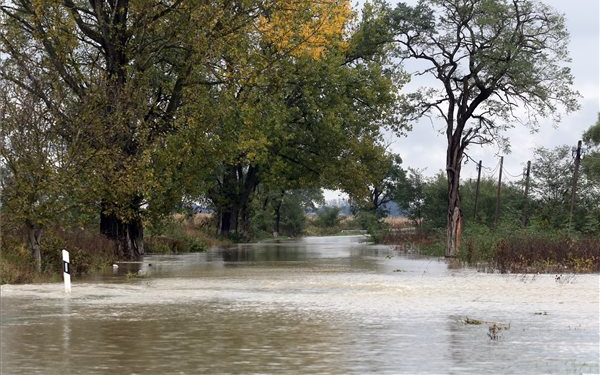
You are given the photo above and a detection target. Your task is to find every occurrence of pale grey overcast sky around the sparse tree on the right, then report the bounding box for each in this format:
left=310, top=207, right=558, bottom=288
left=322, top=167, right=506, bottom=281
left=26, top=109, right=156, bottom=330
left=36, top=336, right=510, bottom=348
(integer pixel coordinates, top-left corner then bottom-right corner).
left=326, top=0, right=600, bottom=203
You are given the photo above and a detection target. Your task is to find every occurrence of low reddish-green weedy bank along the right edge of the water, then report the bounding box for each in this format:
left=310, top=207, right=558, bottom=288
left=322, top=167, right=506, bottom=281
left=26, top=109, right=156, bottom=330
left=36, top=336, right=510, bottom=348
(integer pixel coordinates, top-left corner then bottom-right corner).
left=381, top=225, right=600, bottom=273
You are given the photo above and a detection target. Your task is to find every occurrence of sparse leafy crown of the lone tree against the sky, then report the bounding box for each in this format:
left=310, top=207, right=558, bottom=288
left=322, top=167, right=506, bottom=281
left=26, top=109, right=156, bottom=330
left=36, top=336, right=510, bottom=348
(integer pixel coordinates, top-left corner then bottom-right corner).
left=388, top=0, right=578, bottom=126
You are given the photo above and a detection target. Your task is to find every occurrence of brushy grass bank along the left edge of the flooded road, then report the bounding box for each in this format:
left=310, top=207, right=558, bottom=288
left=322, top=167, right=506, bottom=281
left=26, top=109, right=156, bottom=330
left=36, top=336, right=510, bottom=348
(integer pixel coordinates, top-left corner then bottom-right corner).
left=0, top=215, right=225, bottom=284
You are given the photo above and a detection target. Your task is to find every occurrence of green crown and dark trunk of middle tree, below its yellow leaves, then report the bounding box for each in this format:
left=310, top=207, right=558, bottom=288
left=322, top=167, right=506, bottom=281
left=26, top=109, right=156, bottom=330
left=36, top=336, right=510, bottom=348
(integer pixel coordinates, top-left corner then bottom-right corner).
left=195, top=18, right=400, bottom=238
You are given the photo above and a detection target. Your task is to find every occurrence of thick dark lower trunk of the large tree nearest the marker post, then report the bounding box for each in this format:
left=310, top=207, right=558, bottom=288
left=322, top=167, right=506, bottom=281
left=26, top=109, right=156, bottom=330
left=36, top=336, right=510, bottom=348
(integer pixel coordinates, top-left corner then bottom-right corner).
left=100, top=204, right=145, bottom=259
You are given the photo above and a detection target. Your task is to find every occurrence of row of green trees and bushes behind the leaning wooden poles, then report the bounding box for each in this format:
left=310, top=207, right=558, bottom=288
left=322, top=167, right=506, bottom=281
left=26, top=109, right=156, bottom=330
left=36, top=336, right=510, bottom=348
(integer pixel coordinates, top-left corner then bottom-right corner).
left=396, top=120, right=600, bottom=236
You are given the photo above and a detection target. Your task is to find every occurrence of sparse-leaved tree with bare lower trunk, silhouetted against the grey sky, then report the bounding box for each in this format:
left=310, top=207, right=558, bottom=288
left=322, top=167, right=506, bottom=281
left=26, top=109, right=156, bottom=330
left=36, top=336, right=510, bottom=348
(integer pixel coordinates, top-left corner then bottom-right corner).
left=388, top=0, right=578, bottom=257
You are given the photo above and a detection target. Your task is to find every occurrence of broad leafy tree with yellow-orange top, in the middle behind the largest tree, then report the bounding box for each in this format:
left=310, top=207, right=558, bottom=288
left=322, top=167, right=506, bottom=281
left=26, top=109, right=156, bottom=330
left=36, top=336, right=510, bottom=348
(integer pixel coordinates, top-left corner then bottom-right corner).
left=193, top=1, right=406, bottom=238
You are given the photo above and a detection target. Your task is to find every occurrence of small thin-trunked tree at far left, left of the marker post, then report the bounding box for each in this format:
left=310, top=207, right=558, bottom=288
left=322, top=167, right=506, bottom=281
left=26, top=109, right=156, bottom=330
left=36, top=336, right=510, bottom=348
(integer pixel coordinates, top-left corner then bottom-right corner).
left=0, top=72, right=91, bottom=272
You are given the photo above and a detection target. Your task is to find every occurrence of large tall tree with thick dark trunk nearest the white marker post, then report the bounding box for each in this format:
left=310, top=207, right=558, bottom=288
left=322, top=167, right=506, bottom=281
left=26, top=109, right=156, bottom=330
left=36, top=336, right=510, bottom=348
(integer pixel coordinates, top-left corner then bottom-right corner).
left=0, top=0, right=260, bottom=258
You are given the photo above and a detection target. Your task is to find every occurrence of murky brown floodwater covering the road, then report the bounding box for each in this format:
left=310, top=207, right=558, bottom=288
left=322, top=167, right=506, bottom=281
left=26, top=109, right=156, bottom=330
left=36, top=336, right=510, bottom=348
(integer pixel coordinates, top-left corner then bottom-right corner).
left=0, top=236, right=600, bottom=375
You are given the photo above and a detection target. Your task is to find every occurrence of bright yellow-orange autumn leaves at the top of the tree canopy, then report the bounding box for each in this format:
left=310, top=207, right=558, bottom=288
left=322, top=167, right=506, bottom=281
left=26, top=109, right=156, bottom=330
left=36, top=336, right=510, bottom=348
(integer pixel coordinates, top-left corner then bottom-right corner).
left=258, top=0, right=353, bottom=59
